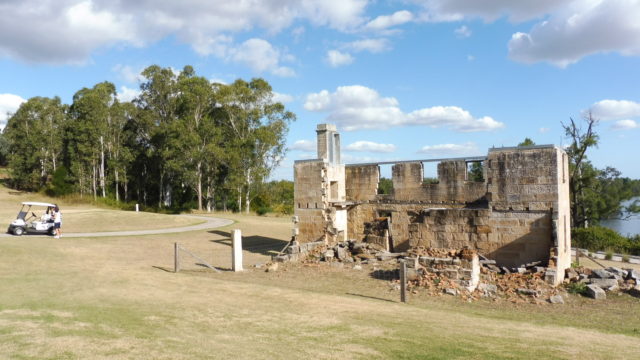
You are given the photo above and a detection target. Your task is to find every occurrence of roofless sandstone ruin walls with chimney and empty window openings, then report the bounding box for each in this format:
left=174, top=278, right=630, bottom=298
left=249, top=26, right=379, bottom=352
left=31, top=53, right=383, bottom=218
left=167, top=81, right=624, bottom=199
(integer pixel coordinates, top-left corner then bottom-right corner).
left=289, top=124, right=571, bottom=285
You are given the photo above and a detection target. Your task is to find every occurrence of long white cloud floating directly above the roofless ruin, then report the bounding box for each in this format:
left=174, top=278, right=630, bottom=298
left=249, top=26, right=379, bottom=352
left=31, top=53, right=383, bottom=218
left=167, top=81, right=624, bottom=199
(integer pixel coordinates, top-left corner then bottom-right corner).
left=304, top=85, right=504, bottom=132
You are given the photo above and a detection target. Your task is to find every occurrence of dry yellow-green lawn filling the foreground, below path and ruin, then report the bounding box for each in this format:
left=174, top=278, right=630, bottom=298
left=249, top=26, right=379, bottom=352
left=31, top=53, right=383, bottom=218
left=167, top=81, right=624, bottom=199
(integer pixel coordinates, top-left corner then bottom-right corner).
left=0, top=184, right=640, bottom=359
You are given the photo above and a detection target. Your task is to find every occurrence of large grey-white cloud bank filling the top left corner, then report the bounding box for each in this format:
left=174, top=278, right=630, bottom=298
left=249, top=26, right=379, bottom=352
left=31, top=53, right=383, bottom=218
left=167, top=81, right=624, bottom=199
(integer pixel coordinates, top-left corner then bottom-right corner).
left=0, top=0, right=368, bottom=65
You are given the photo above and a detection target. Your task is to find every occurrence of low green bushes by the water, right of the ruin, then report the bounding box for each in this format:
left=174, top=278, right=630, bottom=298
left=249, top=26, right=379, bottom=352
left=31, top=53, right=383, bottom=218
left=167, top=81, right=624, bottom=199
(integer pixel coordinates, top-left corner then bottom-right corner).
left=571, top=226, right=640, bottom=255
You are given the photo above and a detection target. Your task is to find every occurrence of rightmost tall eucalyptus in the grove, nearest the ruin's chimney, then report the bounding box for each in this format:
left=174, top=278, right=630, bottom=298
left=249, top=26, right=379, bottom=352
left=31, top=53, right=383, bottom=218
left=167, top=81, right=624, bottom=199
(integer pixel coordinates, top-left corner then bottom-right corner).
left=218, top=78, right=295, bottom=212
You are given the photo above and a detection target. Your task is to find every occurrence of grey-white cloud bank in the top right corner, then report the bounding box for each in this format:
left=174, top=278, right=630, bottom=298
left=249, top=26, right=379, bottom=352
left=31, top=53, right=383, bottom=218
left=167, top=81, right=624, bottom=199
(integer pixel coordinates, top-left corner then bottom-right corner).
left=414, top=0, right=640, bottom=67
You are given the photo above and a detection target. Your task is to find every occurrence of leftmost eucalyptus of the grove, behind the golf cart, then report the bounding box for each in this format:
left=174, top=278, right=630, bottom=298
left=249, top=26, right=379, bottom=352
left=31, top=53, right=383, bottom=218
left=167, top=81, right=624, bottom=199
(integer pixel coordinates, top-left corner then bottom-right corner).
left=4, top=97, right=67, bottom=190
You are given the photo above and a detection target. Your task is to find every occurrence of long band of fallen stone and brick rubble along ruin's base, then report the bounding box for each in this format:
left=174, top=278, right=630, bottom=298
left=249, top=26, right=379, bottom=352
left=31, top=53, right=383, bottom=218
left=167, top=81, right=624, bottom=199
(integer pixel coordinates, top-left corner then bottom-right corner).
left=274, top=241, right=640, bottom=304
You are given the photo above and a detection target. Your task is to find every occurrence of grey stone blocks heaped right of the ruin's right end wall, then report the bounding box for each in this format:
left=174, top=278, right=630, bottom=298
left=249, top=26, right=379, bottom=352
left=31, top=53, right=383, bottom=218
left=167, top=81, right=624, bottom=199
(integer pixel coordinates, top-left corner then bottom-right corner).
left=565, top=267, right=640, bottom=300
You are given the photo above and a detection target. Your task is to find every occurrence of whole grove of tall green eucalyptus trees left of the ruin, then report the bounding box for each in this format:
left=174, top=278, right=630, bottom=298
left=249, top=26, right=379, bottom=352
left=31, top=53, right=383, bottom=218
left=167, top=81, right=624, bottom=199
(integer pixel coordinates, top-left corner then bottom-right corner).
left=0, top=65, right=295, bottom=213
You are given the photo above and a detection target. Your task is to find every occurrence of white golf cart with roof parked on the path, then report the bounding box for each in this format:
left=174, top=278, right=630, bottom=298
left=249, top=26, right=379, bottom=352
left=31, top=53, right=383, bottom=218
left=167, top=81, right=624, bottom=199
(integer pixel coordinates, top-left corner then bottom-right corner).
left=7, top=201, right=56, bottom=236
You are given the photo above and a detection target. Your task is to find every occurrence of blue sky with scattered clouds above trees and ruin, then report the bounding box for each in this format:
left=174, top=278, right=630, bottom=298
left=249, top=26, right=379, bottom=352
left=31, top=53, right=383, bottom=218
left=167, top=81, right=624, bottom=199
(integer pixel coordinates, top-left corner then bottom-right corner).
left=0, top=0, right=640, bottom=179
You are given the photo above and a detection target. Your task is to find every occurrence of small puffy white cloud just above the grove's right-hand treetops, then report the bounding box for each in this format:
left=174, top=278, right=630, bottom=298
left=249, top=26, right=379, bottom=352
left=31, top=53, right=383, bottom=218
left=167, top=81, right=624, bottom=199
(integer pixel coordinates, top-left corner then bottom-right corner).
left=229, top=38, right=295, bottom=77
